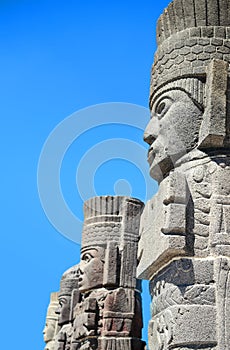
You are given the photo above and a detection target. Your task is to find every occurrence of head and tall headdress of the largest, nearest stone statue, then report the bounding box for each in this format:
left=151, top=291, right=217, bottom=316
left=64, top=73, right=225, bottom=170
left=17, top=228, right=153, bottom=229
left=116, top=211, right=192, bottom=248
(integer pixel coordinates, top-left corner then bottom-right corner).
left=144, top=0, right=230, bottom=181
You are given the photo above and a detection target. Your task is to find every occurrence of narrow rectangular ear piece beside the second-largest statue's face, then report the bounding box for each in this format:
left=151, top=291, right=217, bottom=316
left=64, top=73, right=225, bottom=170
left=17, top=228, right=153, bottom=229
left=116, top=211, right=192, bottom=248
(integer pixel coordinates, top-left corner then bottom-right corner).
left=103, top=241, right=119, bottom=286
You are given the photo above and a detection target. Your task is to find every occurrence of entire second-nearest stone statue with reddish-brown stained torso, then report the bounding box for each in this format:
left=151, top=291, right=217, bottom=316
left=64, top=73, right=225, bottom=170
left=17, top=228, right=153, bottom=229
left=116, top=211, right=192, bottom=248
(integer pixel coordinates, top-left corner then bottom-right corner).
left=71, top=196, right=144, bottom=350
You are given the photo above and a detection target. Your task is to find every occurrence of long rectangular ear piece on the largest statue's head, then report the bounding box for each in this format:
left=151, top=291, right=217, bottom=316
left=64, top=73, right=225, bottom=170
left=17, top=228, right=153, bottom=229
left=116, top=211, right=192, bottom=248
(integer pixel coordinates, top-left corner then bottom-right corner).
left=198, top=60, right=229, bottom=149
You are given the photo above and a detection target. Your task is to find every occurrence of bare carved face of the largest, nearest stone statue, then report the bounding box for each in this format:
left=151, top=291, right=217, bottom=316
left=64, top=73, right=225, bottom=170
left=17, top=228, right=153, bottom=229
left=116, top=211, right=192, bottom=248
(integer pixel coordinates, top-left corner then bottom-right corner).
left=144, top=86, right=203, bottom=181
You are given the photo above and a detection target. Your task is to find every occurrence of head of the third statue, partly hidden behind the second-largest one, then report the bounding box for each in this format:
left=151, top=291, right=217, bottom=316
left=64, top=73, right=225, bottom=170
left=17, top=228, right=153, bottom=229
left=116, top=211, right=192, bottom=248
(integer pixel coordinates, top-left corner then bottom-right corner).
left=56, top=265, right=79, bottom=326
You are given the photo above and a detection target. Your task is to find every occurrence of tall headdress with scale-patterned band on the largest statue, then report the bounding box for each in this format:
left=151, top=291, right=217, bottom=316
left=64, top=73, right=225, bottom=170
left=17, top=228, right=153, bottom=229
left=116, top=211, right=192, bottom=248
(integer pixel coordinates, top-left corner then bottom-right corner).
left=150, top=0, right=230, bottom=102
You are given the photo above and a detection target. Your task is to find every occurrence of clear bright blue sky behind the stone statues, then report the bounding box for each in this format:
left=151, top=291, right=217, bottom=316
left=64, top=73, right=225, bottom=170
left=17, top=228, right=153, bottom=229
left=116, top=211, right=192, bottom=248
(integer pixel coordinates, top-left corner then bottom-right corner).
left=0, top=0, right=169, bottom=350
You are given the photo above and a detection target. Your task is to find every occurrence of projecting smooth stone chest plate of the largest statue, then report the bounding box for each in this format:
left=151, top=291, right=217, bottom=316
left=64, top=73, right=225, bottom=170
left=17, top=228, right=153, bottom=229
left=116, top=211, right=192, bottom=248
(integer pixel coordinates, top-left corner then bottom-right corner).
left=137, top=172, right=190, bottom=279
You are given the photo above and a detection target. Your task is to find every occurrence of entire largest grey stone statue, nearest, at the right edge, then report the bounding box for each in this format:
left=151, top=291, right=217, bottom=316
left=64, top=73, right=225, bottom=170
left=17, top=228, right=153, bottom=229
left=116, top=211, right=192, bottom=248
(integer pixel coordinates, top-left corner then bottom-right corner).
left=137, top=0, right=230, bottom=350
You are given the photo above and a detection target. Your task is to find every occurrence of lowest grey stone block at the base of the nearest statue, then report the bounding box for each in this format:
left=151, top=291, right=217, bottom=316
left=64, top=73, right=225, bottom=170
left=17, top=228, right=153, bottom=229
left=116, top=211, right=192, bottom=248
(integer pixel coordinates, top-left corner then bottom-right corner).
left=149, top=305, right=217, bottom=350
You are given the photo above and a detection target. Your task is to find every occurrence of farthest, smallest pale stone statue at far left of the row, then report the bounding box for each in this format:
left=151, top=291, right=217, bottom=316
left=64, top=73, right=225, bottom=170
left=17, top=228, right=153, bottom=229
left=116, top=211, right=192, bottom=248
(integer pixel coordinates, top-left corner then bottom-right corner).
left=43, top=292, right=58, bottom=350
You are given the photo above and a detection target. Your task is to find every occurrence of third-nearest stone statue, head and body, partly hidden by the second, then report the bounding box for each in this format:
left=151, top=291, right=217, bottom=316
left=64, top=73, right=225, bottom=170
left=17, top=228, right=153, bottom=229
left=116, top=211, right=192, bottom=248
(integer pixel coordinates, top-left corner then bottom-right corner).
left=54, top=265, right=79, bottom=350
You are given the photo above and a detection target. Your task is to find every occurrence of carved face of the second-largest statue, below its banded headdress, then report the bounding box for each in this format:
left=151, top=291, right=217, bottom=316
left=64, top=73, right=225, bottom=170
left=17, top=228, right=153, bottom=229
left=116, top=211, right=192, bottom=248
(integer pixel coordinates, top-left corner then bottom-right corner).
left=78, top=247, right=104, bottom=293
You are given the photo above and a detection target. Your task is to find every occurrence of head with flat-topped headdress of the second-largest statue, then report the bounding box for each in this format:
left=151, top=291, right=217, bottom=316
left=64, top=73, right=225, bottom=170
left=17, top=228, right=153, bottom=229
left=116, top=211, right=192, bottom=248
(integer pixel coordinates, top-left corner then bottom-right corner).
left=79, top=196, right=144, bottom=293
